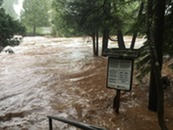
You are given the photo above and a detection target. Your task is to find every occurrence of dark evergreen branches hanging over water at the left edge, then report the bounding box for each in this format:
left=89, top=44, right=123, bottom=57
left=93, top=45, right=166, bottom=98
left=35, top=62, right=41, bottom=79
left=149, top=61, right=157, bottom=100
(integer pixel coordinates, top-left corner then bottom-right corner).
left=0, top=2, right=25, bottom=51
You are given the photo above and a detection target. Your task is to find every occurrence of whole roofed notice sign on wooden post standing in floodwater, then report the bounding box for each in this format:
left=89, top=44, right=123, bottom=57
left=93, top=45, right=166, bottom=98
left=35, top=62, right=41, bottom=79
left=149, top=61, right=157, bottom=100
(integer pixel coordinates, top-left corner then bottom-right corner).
left=103, top=48, right=138, bottom=113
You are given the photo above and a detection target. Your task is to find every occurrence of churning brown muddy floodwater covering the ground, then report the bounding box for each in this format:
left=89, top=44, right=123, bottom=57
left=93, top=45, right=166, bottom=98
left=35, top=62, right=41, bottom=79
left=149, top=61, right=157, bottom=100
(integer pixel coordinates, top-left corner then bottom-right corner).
left=0, top=37, right=173, bottom=130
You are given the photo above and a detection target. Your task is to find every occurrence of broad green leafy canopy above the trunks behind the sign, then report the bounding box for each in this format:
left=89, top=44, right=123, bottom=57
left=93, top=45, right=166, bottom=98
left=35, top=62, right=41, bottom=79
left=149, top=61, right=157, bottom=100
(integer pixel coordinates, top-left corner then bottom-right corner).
left=53, top=0, right=139, bottom=35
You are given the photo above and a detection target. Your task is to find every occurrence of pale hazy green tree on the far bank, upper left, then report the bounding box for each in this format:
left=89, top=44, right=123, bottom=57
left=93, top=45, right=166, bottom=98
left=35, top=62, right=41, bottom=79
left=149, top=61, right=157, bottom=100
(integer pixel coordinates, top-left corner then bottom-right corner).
left=21, top=0, right=50, bottom=34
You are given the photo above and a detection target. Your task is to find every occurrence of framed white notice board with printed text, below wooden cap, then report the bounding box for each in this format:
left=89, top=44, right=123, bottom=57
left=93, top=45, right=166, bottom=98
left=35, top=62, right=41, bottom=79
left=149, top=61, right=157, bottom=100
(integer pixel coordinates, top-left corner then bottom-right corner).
left=106, top=57, right=134, bottom=91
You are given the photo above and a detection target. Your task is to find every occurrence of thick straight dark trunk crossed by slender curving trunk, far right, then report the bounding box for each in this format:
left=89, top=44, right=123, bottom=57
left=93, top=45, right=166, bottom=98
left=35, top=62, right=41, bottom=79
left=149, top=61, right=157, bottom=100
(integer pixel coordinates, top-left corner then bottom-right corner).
left=148, top=1, right=164, bottom=111
